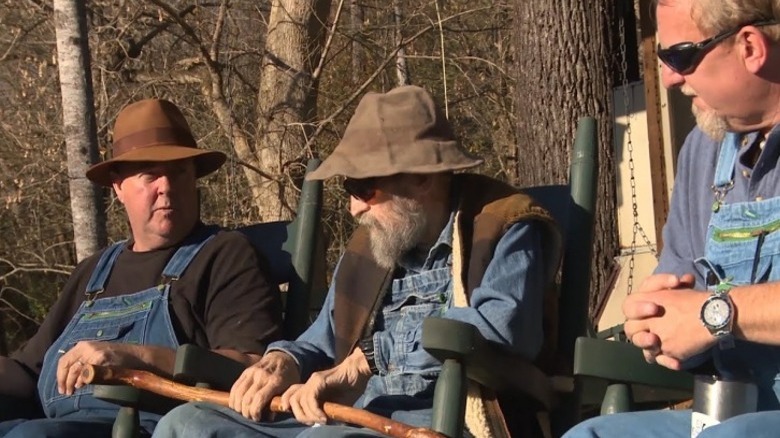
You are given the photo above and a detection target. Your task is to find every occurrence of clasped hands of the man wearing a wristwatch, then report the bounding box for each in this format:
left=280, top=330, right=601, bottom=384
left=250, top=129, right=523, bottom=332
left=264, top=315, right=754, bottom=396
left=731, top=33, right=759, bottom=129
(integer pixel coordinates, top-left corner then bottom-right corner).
left=623, top=274, right=717, bottom=370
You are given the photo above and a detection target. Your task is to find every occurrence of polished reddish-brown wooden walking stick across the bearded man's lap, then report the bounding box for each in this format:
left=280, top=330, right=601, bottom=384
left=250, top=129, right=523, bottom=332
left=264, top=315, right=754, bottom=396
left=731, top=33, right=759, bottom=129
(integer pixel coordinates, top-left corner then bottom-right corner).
left=81, top=365, right=446, bottom=438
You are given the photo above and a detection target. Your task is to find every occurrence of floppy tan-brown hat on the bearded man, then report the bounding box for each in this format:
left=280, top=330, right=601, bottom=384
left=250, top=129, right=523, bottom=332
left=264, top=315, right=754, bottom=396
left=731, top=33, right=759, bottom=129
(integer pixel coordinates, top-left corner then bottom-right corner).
left=307, top=85, right=482, bottom=179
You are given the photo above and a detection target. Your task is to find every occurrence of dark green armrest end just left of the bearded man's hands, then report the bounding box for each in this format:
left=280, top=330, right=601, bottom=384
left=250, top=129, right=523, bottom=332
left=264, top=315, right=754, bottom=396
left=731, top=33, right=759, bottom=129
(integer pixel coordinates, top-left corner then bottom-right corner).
left=173, top=344, right=246, bottom=391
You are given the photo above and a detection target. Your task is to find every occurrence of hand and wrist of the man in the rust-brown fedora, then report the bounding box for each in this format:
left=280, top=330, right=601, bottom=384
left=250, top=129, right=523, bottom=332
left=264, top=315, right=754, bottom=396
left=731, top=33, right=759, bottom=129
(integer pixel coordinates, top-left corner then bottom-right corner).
left=57, top=341, right=155, bottom=395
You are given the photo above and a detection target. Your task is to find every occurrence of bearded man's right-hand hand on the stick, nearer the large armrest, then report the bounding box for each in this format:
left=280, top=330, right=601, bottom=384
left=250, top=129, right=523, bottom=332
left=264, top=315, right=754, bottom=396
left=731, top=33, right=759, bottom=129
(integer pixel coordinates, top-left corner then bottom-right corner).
left=282, top=348, right=371, bottom=424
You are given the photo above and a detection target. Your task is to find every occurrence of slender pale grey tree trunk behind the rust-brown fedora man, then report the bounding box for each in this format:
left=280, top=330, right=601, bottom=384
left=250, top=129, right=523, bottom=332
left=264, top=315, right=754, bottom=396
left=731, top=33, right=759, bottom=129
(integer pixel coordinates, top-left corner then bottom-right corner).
left=54, top=0, right=106, bottom=261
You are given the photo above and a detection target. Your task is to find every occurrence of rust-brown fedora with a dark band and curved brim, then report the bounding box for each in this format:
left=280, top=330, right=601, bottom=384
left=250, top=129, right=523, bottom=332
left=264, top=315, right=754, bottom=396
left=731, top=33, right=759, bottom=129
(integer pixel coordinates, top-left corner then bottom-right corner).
left=87, top=99, right=227, bottom=187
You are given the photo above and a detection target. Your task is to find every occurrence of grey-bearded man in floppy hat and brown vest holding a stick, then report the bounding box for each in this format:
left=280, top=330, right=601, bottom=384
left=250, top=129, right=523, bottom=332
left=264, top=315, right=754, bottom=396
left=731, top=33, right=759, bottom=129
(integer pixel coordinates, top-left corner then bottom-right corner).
left=155, top=86, right=560, bottom=437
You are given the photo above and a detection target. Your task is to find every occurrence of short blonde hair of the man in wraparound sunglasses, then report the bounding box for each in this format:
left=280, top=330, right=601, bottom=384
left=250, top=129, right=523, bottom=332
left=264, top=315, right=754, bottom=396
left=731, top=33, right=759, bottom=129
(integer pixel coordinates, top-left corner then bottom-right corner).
left=691, top=0, right=780, bottom=42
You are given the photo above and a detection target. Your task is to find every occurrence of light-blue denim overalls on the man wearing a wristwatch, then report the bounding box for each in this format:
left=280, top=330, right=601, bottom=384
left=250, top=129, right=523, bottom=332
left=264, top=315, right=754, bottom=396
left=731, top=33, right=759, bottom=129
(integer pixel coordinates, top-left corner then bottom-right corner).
left=696, top=133, right=780, bottom=410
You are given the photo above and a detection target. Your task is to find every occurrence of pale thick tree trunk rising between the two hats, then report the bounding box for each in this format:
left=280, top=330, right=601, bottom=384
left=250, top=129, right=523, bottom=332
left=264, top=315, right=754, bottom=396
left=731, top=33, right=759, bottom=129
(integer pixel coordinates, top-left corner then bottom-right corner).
left=255, top=0, right=331, bottom=220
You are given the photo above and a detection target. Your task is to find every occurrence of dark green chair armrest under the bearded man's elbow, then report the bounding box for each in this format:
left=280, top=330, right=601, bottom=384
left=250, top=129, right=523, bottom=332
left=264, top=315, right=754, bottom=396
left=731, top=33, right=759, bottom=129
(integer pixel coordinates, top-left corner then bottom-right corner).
left=422, top=318, right=555, bottom=409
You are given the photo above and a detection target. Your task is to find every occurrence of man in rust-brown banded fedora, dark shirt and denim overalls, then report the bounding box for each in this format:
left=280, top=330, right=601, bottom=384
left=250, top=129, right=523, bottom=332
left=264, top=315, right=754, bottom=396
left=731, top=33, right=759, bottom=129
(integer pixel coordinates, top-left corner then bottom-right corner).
left=0, top=99, right=281, bottom=437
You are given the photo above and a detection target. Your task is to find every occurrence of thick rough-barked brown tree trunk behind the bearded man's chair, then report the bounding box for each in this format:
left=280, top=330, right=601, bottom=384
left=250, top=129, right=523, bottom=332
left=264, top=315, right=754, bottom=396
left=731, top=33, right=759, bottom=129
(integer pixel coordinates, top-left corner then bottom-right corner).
left=515, top=0, right=618, bottom=322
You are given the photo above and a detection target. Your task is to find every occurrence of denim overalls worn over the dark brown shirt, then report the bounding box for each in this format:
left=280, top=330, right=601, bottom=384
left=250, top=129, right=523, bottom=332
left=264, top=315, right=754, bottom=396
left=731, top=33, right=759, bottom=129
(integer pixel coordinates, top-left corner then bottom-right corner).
left=38, top=233, right=215, bottom=418
